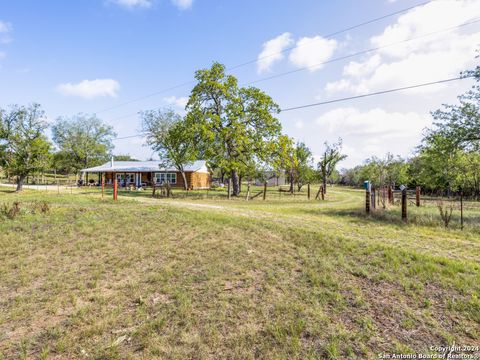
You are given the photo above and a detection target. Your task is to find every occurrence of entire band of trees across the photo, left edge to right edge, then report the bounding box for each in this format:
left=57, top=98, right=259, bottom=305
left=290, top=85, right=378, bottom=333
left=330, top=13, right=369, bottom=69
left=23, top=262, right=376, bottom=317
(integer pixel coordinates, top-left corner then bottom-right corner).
left=0, top=57, right=480, bottom=197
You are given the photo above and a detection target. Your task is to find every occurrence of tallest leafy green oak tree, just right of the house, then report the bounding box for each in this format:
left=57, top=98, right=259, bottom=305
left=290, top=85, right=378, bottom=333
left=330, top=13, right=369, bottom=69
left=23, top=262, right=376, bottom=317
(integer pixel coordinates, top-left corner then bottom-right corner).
left=186, top=63, right=281, bottom=196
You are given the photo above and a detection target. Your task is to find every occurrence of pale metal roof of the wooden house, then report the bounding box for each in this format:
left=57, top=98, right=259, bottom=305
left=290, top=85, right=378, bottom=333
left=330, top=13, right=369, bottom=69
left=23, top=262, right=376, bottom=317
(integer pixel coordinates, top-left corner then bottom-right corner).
left=80, top=160, right=209, bottom=173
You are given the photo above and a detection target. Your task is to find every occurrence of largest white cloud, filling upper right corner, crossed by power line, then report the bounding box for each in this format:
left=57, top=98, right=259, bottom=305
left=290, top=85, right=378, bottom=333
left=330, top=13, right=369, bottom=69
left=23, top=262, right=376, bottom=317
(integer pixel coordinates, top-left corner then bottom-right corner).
left=325, top=0, right=480, bottom=94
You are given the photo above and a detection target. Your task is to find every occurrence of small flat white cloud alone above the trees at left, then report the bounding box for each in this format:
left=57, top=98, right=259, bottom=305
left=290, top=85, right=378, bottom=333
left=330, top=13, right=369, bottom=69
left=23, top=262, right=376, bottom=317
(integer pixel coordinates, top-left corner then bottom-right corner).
left=57, top=79, right=120, bottom=99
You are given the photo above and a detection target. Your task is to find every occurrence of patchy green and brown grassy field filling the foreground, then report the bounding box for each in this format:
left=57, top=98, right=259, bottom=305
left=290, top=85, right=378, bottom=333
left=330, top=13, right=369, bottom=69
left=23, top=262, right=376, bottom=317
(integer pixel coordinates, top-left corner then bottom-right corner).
left=0, top=188, right=480, bottom=359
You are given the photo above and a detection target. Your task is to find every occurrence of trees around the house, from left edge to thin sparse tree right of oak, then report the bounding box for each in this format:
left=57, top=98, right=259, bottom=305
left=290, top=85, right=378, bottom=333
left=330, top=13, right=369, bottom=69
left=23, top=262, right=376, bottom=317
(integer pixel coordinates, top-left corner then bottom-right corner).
left=0, top=63, right=344, bottom=196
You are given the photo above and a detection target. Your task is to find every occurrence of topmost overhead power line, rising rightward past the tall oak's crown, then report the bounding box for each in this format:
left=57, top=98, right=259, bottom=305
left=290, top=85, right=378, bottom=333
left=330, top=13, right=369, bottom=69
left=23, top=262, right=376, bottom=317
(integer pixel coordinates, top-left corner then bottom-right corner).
left=96, top=0, right=436, bottom=114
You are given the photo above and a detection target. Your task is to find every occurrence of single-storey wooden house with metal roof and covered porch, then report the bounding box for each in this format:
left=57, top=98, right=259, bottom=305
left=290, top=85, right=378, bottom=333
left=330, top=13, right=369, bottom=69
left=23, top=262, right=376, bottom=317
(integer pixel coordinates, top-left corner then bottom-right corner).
left=81, top=159, right=211, bottom=190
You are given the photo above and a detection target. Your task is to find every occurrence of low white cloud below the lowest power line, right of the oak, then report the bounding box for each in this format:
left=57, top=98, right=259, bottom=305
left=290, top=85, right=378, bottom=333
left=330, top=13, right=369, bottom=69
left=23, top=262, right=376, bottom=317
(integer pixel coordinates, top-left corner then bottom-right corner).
left=316, top=107, right=432, bottom=166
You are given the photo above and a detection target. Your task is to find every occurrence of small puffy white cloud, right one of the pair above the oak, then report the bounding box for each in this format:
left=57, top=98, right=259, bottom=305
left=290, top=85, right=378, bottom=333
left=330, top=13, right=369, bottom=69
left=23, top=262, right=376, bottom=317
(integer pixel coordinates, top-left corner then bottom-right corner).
left=289, top=36, right=338, bottom=71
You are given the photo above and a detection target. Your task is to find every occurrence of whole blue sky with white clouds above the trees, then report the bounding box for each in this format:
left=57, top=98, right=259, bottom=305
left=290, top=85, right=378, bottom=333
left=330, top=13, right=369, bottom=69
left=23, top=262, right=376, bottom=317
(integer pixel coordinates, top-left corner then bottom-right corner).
left=0, top=0, right=480, bottom=166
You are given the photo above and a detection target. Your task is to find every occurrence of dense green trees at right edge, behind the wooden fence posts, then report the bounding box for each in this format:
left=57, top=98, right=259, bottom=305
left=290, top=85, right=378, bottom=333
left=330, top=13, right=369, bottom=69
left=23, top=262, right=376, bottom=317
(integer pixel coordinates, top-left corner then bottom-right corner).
left=340, top=60, right=480, bottom=199
